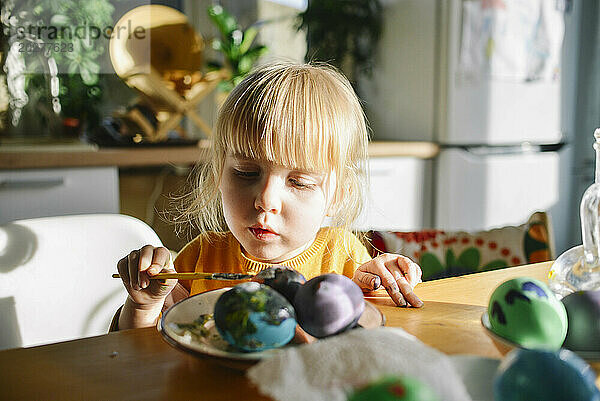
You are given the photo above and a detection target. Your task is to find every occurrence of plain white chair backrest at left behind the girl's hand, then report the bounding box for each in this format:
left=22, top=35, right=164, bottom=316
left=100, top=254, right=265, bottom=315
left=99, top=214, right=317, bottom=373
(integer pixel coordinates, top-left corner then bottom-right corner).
left=0, top=214, right=161, bottom=349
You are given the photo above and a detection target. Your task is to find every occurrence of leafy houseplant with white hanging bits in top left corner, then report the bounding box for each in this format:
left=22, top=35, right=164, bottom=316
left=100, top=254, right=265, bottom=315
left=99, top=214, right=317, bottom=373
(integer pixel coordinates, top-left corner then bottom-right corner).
left=1, top=0, right=114, bottom=136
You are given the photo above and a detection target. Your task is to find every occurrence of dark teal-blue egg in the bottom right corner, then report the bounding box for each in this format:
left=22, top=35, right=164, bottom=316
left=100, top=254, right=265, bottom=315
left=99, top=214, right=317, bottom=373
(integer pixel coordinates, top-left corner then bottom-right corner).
left=494, top=348, right=600, bottom=401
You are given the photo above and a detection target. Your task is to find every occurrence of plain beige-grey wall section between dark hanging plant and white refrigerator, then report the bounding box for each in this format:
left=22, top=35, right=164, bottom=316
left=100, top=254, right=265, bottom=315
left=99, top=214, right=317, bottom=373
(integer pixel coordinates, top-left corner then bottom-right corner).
left=361, top=0, right=440, bottom=141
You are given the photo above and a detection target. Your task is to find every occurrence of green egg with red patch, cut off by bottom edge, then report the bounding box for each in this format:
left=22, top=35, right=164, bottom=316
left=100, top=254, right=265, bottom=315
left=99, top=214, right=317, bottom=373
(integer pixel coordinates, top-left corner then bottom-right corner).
left=348, top=376, right=439, bottom=401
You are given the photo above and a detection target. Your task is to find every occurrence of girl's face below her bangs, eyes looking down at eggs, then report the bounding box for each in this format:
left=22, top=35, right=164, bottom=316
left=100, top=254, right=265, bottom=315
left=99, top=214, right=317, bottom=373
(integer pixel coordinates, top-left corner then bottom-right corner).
left=219, top=154, right=335, bottom=263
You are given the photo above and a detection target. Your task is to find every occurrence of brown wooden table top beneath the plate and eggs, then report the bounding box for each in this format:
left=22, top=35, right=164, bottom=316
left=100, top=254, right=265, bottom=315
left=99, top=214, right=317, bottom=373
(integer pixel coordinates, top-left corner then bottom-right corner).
left=0, top=263, right=600, bottom=400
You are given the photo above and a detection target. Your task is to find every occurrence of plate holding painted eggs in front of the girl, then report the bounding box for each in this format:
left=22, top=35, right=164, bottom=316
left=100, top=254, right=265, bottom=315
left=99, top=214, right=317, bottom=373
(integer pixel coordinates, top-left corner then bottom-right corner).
left=157, top=267, right=385, bottom=368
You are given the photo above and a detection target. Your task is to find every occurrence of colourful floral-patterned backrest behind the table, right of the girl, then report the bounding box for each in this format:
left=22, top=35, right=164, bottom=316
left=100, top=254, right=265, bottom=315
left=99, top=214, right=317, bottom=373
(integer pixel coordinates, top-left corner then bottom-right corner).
left=369, top=212, right=554, bottom=280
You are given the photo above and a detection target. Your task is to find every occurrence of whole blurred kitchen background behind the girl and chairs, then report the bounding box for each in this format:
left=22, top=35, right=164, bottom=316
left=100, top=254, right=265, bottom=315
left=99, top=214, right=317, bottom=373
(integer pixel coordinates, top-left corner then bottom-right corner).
left=0, top=0, right=600, bottom=254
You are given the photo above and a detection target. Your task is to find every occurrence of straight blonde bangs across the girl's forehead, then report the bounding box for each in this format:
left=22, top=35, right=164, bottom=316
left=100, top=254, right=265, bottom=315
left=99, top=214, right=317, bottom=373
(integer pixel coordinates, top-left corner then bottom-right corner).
left=215, top=63, right=362, bottom=172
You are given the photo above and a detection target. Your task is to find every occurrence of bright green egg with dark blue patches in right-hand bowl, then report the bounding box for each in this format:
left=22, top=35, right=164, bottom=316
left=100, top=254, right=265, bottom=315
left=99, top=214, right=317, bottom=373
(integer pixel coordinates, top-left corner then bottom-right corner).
left=488, top=277, right=567, bottom=350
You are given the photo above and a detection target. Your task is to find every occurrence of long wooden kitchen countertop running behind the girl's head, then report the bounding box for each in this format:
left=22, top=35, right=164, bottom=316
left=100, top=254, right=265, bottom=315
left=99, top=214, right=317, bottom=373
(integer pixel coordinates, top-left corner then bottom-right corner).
left=0, top=140, right=439, bottom=169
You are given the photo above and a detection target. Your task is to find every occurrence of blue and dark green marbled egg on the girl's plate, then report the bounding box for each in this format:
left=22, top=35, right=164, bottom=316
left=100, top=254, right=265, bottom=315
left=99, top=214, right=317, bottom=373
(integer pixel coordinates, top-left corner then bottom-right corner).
left=214, top=282, right=296, bottom=351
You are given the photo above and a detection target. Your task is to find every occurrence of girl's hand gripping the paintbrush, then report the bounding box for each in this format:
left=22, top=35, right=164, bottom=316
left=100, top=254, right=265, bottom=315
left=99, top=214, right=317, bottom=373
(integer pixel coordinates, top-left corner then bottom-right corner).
left=117, top=245, right=177, bottom=308
